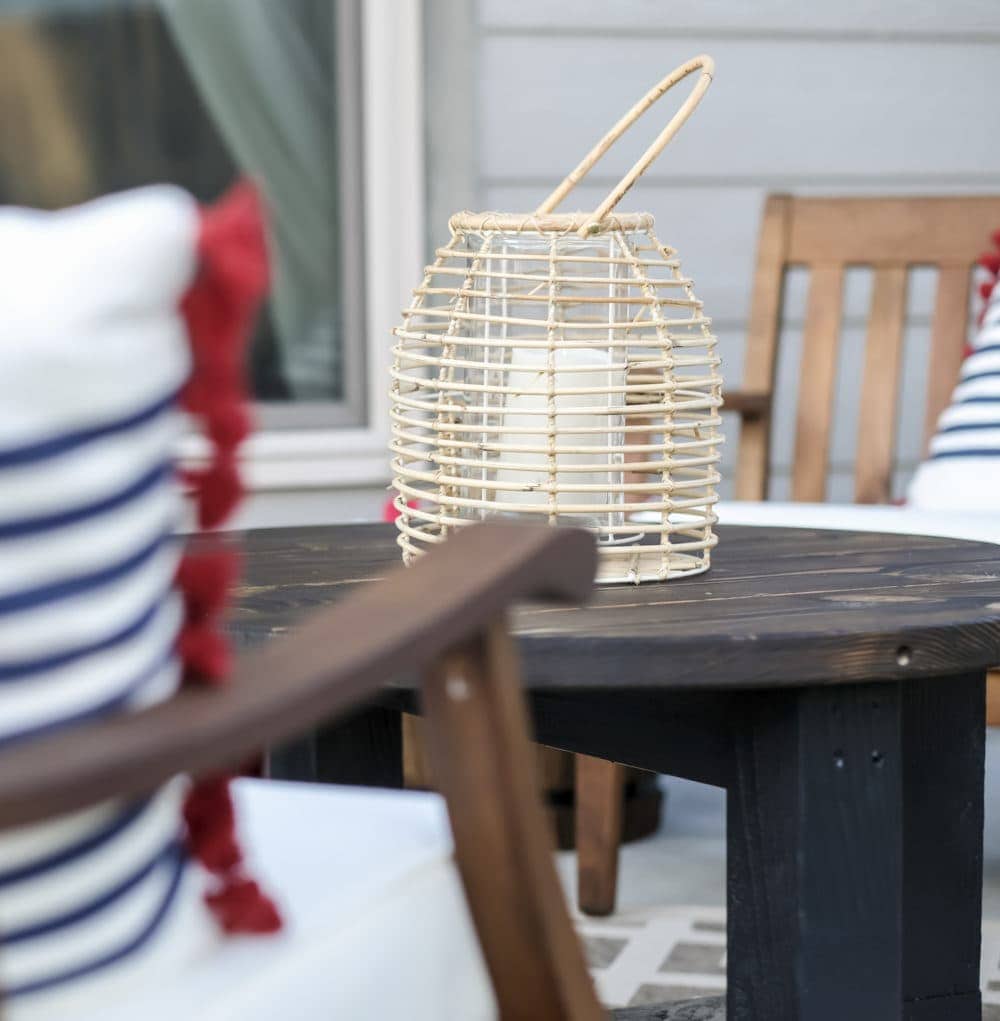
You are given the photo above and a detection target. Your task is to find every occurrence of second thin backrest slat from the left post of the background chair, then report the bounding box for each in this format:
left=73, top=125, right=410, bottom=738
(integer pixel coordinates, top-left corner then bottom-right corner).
left=854, top=265, right=906, bottom=503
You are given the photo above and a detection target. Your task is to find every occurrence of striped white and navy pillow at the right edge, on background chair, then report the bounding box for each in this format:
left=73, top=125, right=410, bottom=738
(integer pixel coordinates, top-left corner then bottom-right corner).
left=907, top=271, right=1000, bottom=514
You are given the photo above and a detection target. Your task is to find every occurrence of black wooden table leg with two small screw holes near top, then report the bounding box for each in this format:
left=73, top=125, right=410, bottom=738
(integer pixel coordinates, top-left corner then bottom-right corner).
left=727, top=685, right=903, bottom=1021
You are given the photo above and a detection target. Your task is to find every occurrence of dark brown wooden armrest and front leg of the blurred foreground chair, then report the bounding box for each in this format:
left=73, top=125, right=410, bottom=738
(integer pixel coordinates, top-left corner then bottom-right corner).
left=0, top=524, right=686, bottom=1021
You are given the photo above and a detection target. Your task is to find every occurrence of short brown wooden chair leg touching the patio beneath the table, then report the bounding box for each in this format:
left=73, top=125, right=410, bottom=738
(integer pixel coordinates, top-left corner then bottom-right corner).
left=576, top=755, right=624, bottom=915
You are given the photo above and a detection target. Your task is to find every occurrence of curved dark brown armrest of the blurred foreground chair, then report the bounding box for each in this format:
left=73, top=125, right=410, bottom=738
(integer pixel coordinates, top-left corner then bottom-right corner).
left=0, top=524, right=596, bottom=829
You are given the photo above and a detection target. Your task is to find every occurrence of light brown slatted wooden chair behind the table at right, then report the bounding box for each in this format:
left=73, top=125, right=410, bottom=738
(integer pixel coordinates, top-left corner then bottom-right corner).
left=577, top=195, right=1000, bottom=914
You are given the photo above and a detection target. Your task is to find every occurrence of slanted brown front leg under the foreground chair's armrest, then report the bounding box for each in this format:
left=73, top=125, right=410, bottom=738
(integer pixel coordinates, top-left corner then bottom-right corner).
left=423, top=620, right=606, bottom=1021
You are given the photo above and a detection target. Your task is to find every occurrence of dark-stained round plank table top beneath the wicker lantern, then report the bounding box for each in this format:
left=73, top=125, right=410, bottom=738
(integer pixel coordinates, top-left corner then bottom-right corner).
left=230, top=524, right=1000, bottom=690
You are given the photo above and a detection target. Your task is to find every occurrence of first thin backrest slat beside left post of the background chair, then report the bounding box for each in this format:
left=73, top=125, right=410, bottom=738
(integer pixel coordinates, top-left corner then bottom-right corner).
left=792, top=262, right=844, bottom=502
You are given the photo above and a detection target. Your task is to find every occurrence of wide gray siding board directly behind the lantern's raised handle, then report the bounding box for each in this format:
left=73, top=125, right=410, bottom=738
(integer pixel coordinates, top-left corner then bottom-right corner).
left=478, top=34, right=1000, bottom=183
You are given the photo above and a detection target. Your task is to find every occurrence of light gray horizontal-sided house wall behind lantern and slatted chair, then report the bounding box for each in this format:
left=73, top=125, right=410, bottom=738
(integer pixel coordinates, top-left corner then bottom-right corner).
left=451, top=0, right=1000, bottom=499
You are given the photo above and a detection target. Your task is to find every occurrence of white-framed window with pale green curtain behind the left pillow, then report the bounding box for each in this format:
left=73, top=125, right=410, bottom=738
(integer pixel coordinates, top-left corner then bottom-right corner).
left=0, top=0, right=423, bottom=487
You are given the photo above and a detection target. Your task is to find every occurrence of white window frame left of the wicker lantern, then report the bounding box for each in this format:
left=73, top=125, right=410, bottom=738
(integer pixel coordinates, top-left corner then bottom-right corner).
left=182, top=0, right=425, bottom=492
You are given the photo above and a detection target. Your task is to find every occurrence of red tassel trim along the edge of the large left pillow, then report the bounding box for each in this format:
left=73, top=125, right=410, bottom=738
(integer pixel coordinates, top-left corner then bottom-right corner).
left=177, top=184, right=281, bottom=933
